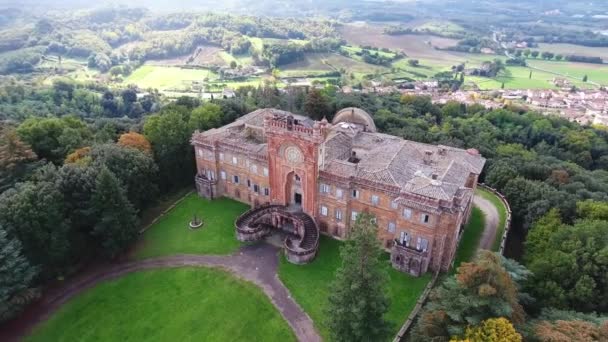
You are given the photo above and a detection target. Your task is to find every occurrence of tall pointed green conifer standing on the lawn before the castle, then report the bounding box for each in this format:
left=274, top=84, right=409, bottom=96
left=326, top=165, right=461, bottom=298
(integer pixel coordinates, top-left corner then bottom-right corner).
left=327, top=213, right=389, bottom=341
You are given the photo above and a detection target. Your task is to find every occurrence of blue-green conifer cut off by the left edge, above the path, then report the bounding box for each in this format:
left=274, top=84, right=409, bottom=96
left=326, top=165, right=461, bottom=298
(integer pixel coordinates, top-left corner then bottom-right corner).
left=0, top=226, right=38, bottom=322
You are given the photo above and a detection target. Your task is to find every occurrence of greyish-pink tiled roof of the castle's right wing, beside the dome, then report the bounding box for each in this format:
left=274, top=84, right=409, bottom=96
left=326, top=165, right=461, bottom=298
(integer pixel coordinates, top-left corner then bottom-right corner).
left=322, top=124, right=485, bottom=201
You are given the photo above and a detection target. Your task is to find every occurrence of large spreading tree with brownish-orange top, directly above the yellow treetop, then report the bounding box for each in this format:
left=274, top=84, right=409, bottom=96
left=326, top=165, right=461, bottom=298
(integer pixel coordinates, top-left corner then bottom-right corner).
left=412, top=251, right=523, bottom=341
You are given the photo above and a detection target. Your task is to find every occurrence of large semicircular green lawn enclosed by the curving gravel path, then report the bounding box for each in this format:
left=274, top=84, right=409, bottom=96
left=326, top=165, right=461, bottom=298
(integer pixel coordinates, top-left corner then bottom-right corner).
left=26, top=268, right=296, bottom=342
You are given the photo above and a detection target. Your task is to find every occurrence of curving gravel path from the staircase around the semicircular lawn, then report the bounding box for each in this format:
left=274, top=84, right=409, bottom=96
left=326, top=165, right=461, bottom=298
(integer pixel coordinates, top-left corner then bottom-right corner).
left=0, top=243, right=321, bottom=342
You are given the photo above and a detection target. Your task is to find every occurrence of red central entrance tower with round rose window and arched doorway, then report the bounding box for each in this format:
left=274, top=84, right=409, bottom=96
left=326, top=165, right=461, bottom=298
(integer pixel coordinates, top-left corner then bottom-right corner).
left=264, top=114, right=327, bottom=217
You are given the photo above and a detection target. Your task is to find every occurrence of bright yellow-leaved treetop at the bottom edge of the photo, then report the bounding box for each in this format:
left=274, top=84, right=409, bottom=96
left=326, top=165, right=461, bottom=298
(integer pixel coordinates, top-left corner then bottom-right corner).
left=450, top=317, right=522, bottom=342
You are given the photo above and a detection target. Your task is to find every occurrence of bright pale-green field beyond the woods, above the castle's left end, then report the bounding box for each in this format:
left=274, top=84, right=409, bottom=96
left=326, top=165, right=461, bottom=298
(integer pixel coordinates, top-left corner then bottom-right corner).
left=122, top=65, right=217, bottom=91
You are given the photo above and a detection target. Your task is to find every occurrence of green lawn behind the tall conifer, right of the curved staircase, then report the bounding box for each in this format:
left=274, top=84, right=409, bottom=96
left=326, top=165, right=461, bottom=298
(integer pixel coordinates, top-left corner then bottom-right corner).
left=279, top=236, right=431, bottom=341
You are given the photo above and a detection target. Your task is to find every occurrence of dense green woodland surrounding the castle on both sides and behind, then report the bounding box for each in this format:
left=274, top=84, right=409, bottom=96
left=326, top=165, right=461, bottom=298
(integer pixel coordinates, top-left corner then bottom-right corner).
left=0, top=77, right=608, bottom=340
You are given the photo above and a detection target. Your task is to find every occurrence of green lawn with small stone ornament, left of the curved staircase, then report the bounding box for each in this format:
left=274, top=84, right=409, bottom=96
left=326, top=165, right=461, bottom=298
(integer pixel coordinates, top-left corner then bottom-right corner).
left=134, top=193, right=248, bottom=259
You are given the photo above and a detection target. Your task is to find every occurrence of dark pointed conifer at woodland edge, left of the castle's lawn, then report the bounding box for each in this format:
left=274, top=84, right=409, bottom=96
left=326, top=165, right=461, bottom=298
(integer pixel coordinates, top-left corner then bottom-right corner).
left=91, top=167, right=137, bottom=257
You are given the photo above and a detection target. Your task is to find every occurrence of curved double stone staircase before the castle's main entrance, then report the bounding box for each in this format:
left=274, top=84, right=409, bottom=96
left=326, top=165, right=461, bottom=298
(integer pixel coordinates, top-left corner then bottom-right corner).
left=235, top=205, right=319, bottom=264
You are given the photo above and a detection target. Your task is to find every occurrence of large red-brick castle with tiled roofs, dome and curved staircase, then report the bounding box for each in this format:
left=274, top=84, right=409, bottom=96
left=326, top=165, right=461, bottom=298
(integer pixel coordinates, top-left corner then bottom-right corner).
left=192, top=108, right=485, bottom=275
